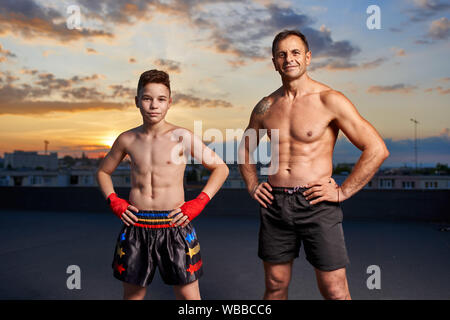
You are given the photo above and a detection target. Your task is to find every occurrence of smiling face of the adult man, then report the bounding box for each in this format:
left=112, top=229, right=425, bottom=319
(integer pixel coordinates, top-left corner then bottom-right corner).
left=272, top=36, right=311, bottom=80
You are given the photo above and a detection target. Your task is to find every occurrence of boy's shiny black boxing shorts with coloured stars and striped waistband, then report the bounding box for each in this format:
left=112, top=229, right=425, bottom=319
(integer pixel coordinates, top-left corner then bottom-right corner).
left=112, top=211, right=203, bottom=287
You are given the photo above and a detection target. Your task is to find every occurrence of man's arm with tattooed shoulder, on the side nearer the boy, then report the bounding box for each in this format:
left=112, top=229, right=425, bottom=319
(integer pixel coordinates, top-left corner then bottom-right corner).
left=238, top=97, right=273, bottom=208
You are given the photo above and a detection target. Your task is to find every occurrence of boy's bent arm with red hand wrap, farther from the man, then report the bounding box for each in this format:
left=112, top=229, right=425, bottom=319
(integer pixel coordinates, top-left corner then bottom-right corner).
left=96, top=134, right=139, bottom=226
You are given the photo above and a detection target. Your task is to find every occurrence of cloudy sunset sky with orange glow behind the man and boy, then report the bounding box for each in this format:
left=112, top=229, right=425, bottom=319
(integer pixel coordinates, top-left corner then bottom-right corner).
left=0, top=0, right=450, bottom=165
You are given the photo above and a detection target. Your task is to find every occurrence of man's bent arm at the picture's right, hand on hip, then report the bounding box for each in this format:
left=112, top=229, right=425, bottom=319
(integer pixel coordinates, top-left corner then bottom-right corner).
left=306, top=92, right=389, bottom=204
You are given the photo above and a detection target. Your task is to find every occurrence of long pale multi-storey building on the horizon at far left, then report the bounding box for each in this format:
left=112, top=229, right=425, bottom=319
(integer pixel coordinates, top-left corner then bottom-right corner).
left=4, top=150, right=58, bottom=170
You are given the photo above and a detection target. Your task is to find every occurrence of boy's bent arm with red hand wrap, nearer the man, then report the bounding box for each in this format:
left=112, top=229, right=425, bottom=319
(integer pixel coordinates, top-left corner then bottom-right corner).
left=168, top=130, right=229, bottom=227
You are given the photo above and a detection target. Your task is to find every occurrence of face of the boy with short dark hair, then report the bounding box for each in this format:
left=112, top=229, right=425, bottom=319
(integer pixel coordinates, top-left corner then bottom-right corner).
left=135, top=83, right=172, bottom=124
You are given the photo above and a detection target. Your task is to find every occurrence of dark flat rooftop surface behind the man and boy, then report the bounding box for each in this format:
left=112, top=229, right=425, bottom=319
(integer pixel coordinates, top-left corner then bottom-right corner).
left=0, top=210, right=450, bottom=300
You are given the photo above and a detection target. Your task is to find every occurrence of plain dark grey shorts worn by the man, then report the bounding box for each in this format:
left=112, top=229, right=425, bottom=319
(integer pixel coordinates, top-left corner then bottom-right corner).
left=258, top=187, right=350, bottom=271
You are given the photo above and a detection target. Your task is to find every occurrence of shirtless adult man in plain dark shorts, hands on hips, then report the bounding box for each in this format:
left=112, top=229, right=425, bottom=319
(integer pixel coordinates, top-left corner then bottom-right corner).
left=239, top=30, right=389, bottom=299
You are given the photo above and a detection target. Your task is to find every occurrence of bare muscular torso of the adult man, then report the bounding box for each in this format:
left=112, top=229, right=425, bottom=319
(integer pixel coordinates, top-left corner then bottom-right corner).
left=262, top=86, right=339, bottom=187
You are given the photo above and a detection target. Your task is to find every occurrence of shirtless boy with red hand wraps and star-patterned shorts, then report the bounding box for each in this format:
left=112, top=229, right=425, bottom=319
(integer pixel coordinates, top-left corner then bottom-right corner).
left=97, top=70, right=228, bottom=299
